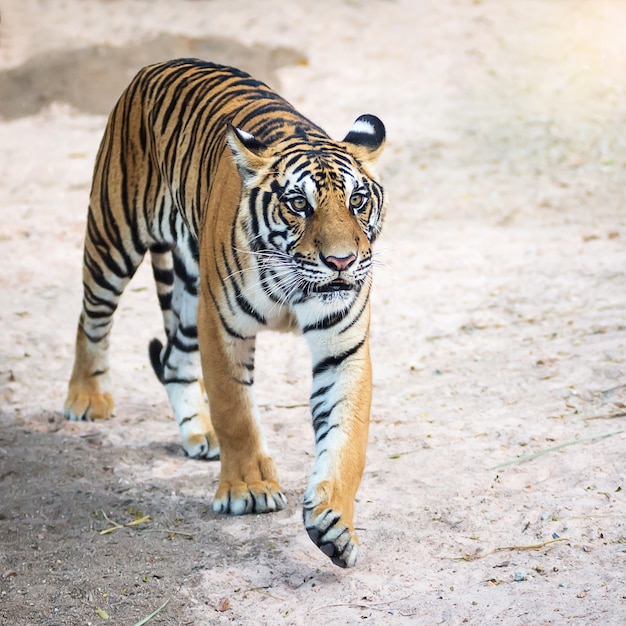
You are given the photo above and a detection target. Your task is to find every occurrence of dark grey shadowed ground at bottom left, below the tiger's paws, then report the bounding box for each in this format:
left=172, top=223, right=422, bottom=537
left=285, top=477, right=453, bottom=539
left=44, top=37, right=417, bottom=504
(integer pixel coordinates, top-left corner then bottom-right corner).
left=0, top=413, right=299, bottom=626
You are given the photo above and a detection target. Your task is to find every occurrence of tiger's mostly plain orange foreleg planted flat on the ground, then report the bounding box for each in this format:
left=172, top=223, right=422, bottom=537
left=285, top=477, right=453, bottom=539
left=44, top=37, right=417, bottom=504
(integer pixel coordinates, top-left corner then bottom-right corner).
left=198, top=284, right=287, bottom=515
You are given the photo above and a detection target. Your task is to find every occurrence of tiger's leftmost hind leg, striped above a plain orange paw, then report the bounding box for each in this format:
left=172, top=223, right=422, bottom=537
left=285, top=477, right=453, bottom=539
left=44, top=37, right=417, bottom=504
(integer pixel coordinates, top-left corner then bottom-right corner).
left=63, top=209, right=144, bottom=421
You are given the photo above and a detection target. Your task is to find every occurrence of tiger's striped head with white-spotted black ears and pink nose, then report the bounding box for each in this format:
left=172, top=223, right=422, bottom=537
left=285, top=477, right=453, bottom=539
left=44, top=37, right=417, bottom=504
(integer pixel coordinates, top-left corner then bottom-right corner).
left=227, top=115, right=385, bottom=308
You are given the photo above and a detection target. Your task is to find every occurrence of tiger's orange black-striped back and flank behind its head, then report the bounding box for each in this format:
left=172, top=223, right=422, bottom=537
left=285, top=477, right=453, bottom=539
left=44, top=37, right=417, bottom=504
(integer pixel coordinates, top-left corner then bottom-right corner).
left=98, top=59, right=328, bottom=239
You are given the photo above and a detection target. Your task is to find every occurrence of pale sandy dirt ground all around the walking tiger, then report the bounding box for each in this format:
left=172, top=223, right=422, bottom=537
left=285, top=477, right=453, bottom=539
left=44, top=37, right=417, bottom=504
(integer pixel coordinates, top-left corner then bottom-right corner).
left=0, top=0, right=626, bottom=626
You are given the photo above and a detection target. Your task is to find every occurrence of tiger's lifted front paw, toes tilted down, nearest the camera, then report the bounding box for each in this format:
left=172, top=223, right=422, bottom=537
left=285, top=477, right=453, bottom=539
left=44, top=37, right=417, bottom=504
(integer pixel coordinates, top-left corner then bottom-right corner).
left=303, top=501, right=359, bottom=567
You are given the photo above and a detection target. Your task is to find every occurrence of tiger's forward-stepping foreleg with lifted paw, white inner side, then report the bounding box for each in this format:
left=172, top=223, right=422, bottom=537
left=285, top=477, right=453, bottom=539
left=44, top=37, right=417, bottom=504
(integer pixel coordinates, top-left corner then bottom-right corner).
left=303, top=316, right=372, bottom=567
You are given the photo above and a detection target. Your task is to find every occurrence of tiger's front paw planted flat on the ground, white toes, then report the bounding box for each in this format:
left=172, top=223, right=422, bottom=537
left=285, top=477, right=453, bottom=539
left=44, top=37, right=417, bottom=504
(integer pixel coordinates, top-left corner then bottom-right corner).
left=213, top=480, right=287, bottom=515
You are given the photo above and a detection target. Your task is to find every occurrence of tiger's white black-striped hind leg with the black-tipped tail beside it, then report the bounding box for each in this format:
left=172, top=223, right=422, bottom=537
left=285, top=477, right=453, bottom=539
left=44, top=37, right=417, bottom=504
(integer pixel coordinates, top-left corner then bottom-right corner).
left=150, top=232, right=220, bottom=459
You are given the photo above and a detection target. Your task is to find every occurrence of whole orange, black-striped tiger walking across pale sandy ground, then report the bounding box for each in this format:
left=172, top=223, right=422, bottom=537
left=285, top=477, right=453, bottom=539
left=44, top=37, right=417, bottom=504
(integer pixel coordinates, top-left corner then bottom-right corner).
left=63, top=59, right=386, bottom=567
